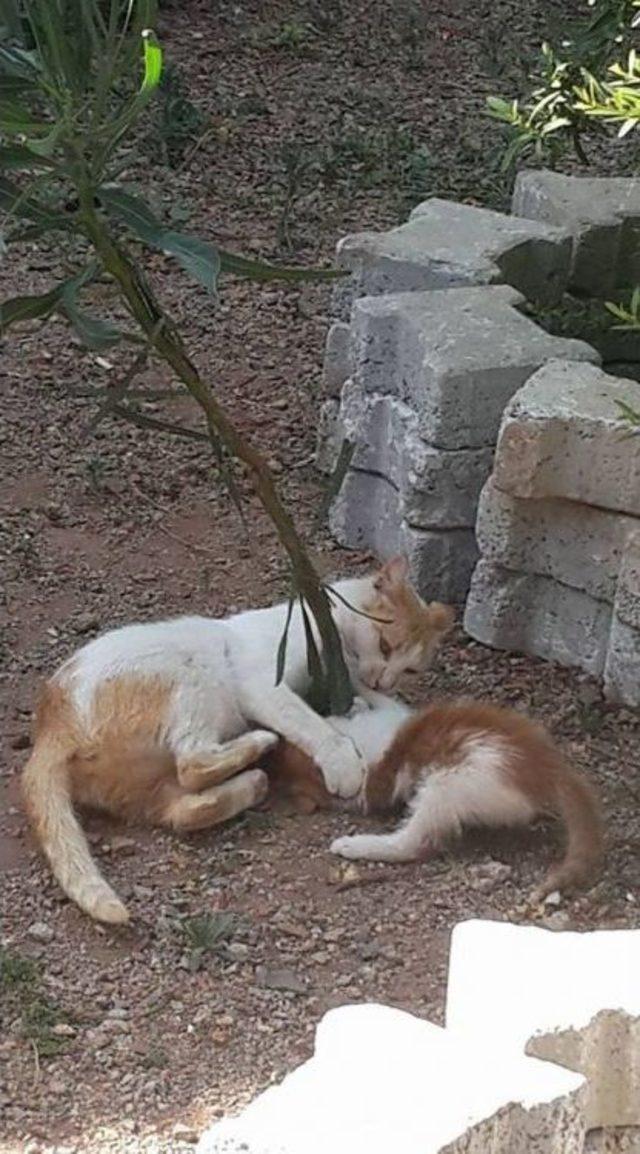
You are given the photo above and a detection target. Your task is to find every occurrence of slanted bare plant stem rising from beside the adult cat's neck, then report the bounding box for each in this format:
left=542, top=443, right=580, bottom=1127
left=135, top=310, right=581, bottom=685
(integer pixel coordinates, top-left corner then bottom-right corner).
left=80, top=204, right=353, bottom=714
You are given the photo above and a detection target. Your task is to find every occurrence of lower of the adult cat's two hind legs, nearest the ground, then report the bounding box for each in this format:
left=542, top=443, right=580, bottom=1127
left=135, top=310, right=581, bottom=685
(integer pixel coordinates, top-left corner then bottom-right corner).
left=163, top=770, right=269, bottom=833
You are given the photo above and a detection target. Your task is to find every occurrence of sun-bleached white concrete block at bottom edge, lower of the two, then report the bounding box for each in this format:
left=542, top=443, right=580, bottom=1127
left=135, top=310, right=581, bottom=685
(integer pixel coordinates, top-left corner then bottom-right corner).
left=197, top=1005, right=585, bottom=1154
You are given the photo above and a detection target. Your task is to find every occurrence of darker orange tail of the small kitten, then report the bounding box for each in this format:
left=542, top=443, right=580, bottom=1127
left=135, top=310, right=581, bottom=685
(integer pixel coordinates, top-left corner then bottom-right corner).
left=537, top=764, right=604, bottom=898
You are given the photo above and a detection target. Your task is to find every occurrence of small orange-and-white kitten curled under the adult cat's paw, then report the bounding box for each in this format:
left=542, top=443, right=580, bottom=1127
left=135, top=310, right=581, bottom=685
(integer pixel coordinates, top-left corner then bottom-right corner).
left=266, top=700, right=603, bottom=900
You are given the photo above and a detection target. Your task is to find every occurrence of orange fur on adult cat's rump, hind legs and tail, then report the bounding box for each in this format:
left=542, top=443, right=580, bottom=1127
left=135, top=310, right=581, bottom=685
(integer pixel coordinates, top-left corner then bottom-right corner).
left=22, top=676, right=268, bottom=923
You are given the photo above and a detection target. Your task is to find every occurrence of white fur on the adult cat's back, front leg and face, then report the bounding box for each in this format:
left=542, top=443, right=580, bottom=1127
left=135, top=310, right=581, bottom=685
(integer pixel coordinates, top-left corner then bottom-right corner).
left=58, top=578, right=405, bottom=797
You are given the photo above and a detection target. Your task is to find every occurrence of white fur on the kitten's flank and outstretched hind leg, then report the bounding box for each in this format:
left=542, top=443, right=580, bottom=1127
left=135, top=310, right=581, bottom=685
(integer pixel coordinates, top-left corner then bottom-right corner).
left=331, top=736, right=536, bottom=862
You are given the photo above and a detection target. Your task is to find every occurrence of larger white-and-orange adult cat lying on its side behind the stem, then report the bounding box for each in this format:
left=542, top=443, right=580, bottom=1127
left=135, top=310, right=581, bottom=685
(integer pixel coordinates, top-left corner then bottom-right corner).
left=22, top=557, right=450, bottom=923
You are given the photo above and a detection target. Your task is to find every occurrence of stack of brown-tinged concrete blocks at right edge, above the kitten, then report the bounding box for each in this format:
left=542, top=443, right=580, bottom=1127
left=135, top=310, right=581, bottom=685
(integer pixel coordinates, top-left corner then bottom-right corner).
left=465, top=361, right=640, bottom=705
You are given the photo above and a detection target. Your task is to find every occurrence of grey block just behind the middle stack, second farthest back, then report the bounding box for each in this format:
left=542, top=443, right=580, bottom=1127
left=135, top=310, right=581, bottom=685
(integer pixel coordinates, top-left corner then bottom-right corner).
left=337, top=197, right=571, bottom=308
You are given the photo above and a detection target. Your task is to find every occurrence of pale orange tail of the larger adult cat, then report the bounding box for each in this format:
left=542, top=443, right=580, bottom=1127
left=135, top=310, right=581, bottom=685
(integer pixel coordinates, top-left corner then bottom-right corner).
left=22, top=690, right=129, bottom=923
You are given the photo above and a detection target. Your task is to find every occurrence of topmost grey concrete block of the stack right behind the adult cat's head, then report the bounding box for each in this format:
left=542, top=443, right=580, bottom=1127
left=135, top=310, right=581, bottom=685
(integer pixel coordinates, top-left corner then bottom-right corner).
left=352, top=285, right=598, bottom=449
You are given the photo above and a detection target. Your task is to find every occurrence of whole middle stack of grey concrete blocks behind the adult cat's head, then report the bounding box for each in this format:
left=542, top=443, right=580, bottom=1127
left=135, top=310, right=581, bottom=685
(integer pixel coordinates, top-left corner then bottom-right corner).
left=321, top=285, right=597, bottom=601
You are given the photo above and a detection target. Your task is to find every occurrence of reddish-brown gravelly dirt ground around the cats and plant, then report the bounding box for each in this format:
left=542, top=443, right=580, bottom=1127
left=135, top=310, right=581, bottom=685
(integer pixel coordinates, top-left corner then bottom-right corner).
left=0, top=0, right=640, bottom=1154
